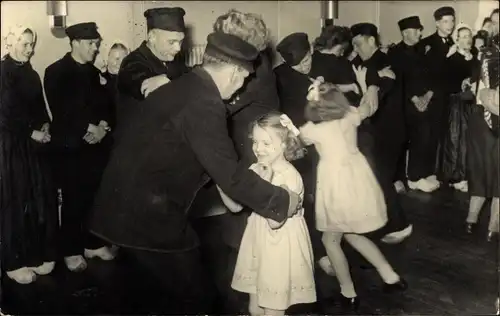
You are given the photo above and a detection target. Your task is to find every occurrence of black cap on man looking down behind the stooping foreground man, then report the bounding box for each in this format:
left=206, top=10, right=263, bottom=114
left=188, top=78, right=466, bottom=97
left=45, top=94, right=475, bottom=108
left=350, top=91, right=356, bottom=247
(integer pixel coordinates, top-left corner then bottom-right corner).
left=144, top=7, right=186, bottom=32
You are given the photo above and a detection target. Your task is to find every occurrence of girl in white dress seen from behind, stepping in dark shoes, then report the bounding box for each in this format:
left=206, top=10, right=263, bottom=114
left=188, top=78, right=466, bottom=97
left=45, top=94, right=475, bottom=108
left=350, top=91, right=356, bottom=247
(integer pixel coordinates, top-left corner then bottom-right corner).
left=300, top=81, right=407, bottom=309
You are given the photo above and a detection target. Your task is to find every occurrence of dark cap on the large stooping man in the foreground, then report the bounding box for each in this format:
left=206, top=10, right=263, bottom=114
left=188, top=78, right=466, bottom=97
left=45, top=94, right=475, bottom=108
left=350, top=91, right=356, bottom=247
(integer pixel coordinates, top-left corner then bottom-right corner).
left=205, top=32, right=259, bottom=72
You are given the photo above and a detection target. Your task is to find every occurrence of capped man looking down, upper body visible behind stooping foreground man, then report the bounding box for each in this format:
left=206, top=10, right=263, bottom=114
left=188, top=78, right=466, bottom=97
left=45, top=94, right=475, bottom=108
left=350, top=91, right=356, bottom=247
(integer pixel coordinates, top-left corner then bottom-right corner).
left=118, top=8, right=188, bottom=100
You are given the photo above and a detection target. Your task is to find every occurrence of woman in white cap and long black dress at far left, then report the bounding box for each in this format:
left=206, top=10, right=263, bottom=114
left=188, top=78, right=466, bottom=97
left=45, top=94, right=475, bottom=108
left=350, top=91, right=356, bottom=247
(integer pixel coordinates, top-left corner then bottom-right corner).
left=0, top=26, right=57, bottom=284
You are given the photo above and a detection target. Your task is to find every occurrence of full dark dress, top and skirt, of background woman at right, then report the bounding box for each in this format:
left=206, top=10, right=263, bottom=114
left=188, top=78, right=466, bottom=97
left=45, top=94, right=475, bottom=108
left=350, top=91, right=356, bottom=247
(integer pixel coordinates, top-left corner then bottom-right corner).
left=436, top=53, right=478, bottom=183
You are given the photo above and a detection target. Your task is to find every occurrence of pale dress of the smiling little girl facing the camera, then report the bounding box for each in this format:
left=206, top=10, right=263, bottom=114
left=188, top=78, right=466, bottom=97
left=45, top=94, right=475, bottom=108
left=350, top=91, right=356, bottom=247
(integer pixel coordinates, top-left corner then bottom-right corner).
left=232, top=164, right=316, bottom=310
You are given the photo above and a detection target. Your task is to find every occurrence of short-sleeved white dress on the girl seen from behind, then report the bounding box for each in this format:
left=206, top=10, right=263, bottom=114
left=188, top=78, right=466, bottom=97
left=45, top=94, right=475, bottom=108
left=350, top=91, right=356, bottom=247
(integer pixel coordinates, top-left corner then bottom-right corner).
left=300, top=107, right=387, bottom=234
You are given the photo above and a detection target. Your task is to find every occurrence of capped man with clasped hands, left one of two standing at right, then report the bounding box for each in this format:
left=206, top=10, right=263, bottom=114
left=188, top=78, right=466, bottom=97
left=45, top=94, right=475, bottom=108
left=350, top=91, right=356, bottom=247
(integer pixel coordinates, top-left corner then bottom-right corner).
left=388, top=16, right=438, bottom=192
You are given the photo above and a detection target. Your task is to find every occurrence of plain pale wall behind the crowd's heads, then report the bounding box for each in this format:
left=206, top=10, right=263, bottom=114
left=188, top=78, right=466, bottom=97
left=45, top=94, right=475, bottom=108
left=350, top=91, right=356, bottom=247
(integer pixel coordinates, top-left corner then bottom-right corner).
left=1, top=0, right=498, bottom=77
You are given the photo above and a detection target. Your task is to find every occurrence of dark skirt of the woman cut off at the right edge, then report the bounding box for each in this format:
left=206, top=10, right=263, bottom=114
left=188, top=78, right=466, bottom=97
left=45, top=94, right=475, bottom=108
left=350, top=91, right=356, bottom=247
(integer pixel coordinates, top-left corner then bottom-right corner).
left=467, top=105, right=500, bottom=197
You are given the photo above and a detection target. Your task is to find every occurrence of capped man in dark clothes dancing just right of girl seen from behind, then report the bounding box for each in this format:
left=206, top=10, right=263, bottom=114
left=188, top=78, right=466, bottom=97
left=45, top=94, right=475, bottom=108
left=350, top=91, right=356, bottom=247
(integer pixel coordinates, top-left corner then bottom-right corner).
left=351, top=23, right=412, bottom=243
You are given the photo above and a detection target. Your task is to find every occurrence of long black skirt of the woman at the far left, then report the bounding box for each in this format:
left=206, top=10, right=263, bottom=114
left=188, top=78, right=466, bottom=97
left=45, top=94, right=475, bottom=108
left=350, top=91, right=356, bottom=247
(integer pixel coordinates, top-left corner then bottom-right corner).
left=0, top=132, right=58, bottom=271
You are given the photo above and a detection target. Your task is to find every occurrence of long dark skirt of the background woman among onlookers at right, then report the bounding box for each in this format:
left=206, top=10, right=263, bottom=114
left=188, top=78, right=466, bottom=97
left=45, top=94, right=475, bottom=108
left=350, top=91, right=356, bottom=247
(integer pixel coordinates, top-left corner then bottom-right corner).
left=436, top=94, right=473, bottom=183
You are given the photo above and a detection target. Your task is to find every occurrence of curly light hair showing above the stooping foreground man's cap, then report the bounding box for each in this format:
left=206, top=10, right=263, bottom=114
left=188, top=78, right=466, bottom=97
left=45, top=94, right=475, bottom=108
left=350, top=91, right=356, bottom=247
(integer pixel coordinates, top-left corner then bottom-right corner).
left=213, top=9, right=269, bottom=51
